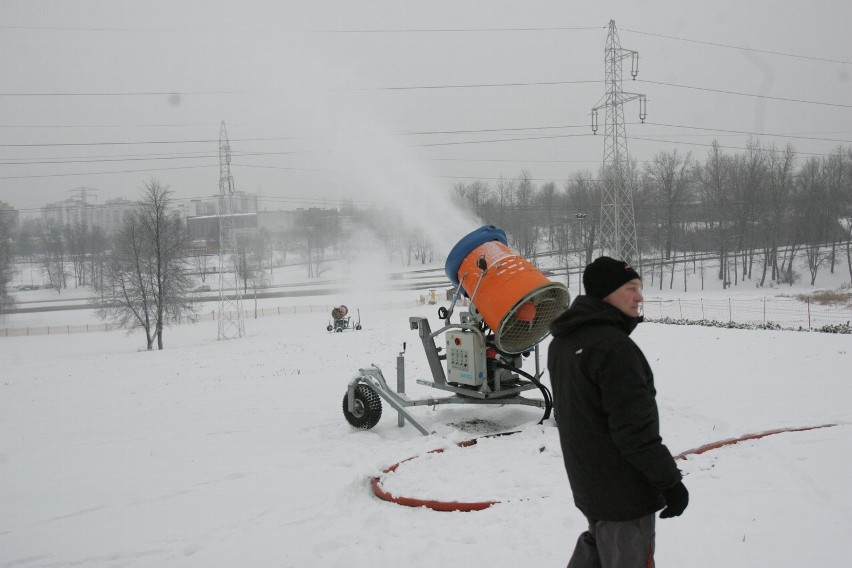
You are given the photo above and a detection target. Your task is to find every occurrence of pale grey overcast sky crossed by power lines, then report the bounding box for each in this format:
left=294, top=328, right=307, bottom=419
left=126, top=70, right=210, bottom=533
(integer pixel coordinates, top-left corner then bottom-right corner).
left=0, top=0, right=852, bottom=217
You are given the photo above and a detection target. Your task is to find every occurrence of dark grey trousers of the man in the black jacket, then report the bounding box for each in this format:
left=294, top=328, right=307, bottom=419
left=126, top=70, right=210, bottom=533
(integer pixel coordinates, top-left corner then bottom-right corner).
left=568, top=514, right=656, bottom=568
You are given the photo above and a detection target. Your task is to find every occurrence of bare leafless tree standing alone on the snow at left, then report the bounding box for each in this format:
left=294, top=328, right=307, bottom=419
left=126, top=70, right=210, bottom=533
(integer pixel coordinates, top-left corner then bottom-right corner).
left=98, top=180, right=195, bottom=351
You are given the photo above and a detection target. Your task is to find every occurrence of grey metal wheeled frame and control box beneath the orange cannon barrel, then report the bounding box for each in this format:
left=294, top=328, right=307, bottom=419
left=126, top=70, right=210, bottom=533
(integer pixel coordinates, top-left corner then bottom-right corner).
left=343, top=316, right=553, bottom=436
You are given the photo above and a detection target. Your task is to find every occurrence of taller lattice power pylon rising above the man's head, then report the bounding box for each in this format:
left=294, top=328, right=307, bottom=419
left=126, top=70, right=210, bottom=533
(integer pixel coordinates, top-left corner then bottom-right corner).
left=592, top=20, right=646, bottom=262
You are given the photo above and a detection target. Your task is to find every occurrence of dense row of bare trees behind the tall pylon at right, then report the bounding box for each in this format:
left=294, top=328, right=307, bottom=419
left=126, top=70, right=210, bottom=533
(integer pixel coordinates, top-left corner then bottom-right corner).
left=454, top=141, right=852, bottom=286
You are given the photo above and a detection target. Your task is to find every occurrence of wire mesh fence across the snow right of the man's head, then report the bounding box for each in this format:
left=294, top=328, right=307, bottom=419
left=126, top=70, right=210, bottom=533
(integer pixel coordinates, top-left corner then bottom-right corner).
left=643, top=298, right=852, bottom=329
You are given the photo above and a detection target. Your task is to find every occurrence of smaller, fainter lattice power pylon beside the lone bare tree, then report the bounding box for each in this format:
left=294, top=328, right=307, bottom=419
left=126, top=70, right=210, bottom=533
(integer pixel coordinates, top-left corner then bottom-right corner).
left=219, top=121, right=245, bottom=339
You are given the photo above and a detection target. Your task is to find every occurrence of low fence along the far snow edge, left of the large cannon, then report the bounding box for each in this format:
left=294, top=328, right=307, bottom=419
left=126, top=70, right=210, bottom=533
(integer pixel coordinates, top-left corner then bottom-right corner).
left=0, top=297, right=426, bottom=337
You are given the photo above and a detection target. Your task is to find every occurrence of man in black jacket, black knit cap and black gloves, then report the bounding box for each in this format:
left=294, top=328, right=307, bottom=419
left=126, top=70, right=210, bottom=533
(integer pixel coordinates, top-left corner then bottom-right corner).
left=547, top=256, right=689, bottom=568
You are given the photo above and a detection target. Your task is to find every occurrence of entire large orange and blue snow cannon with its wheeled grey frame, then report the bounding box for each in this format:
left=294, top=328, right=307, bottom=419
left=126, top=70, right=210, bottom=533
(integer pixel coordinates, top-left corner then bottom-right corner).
left=343, top=225, right=570, bottom=435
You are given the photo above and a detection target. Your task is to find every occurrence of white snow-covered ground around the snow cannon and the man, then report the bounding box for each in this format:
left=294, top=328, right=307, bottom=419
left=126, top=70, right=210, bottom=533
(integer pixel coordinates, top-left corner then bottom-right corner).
left=0, top=258, right=852, bottom=568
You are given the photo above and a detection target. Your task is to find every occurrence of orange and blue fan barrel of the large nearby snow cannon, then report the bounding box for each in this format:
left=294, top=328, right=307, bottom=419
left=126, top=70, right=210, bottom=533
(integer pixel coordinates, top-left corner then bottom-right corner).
left=444, top=225, right=570, bottom=354
